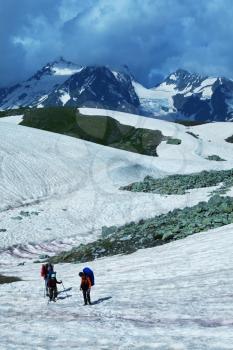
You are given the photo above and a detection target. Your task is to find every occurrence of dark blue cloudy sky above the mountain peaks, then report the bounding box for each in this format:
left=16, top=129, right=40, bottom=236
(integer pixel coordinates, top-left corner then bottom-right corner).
left=0, top=0, right=233, bottom=86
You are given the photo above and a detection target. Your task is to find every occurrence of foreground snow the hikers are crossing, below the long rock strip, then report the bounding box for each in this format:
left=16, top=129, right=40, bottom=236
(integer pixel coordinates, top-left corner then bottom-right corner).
left=0, top=225, right=233, bottom=350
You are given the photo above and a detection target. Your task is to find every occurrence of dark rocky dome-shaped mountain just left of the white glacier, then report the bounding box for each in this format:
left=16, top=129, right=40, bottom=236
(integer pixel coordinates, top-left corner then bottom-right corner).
left=43, top=67, right=139, bottom=113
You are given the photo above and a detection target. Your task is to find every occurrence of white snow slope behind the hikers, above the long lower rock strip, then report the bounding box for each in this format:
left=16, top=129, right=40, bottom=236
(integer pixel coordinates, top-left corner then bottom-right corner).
left=0, top=109, right=233, bottom=261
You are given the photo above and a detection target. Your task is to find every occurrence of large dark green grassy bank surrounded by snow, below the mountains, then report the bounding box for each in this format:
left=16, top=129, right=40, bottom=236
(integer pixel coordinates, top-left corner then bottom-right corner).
left=20, top=107, right=166, bottom=156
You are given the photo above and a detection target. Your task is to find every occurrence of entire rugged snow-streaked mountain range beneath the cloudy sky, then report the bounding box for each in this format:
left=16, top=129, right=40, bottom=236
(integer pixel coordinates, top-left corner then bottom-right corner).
left=0, top=57, right=233, bottom=121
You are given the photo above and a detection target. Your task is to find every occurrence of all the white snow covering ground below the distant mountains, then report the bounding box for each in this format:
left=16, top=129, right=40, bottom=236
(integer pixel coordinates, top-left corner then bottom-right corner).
left=0, top=109, right=233, bottom=350
